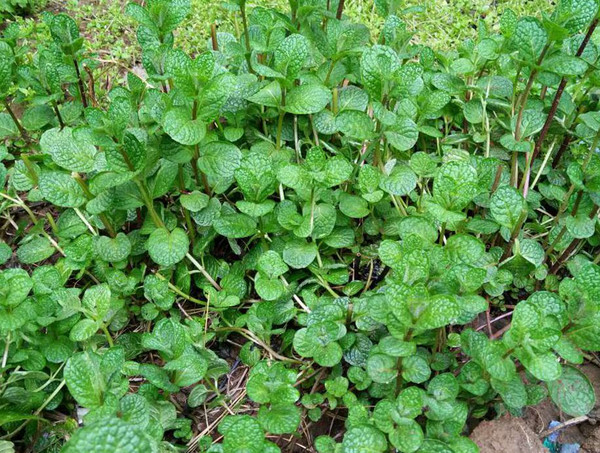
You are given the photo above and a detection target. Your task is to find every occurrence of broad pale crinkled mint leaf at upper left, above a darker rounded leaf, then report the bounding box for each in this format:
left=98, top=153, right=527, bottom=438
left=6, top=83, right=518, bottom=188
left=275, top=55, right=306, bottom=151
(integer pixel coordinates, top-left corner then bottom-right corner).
left=40, top=127, right=97, bottom=172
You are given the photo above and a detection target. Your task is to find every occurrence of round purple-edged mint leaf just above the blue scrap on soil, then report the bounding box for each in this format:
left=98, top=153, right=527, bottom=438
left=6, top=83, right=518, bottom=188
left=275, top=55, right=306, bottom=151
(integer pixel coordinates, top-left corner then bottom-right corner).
left=548, top=366, right=596, bottom=417
